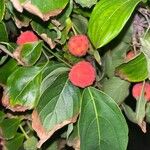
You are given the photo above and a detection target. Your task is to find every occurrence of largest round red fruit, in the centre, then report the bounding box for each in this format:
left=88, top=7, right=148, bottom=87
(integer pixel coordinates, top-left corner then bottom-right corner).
left=69, top=61, right=96, bottom=88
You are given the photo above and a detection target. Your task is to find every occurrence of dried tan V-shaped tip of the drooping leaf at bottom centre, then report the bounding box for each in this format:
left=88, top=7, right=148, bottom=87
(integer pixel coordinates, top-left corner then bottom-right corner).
left=32, top=110, right=78, bottom=148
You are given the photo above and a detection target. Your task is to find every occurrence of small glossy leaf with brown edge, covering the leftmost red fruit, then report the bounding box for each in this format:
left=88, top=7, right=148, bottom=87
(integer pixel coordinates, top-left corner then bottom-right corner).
left=17, top=41, right=42, bottom=66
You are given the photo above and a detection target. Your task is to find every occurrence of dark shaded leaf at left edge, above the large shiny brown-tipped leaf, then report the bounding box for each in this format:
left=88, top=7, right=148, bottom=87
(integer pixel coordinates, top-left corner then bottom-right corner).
left=0, top=59, right=18, bottom=85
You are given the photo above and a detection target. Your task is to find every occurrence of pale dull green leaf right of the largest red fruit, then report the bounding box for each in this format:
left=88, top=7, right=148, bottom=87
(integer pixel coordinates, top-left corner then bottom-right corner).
left=102, top=77, right=130, bottom=104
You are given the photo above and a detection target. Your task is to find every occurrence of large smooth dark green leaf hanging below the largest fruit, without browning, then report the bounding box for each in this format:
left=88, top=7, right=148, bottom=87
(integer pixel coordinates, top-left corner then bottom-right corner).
left=79, top=87, right=128, bottom=150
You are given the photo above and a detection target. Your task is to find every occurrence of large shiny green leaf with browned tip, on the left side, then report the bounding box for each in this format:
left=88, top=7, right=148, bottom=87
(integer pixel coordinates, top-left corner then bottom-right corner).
left=3, top=65, right=46, bottom=111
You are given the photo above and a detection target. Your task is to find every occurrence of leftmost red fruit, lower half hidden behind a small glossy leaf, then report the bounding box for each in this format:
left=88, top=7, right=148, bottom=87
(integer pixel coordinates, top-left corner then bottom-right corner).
left=17, top=31, right=38, bottom=45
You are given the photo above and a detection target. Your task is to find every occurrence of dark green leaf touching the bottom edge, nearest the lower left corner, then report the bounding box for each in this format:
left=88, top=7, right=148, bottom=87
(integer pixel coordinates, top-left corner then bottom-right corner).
left=4, top=133, right=24, bottom=150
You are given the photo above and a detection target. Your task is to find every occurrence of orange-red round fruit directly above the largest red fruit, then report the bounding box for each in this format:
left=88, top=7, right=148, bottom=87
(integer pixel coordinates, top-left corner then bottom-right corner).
left=68, top=34, right=89, bottom=57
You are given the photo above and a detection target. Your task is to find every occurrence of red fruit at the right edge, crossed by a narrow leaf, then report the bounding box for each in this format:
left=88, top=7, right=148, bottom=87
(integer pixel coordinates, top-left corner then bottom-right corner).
left=132, top=83, right=150, bottom=101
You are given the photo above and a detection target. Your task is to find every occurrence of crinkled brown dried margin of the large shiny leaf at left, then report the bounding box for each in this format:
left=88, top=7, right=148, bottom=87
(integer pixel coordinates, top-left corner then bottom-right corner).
left=2, top=91, right=28, bottom=112
